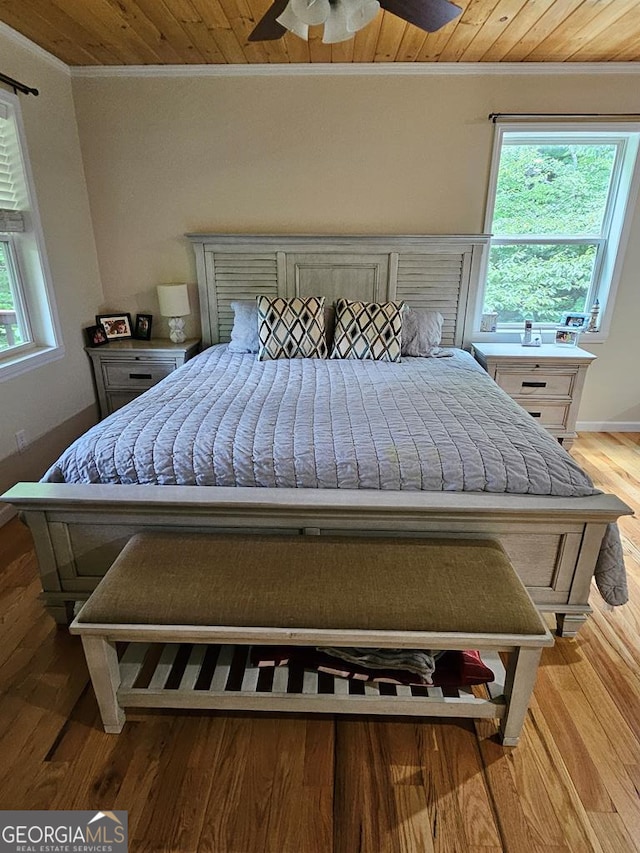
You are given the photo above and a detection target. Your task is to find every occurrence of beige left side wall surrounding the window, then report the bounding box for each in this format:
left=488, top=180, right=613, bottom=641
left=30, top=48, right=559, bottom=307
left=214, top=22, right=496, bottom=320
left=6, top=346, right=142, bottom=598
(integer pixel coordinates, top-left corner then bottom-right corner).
left=0, top=29, right=102, bottom=470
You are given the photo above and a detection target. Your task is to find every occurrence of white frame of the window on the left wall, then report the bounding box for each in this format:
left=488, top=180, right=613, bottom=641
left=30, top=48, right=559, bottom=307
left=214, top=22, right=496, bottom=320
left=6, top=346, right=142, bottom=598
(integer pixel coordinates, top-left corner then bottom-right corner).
left=0, top=90, right=64, bottom=382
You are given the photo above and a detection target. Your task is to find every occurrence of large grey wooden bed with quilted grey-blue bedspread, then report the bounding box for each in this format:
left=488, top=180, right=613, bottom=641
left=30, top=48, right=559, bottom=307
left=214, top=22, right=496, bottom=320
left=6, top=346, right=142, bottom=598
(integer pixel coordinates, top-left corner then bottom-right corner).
left=0, top=235, right=630, bottom=635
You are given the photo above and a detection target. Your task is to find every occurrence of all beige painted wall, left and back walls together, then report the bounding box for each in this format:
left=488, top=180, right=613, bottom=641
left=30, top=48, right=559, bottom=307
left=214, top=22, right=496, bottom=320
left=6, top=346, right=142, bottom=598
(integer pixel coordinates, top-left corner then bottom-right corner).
left=0, top=55, right=640, bottom=486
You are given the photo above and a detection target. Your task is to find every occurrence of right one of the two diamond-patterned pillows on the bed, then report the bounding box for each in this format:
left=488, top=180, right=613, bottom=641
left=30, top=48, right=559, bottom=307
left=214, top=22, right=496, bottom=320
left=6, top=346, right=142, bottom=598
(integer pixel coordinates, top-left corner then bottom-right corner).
left=331, top=299, right=404, bottom=361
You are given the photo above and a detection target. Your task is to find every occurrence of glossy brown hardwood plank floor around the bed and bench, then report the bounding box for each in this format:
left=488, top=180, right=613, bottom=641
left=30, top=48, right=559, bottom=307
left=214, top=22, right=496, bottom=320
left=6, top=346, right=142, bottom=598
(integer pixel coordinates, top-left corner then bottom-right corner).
left=0, top=433, right=640, bottom=853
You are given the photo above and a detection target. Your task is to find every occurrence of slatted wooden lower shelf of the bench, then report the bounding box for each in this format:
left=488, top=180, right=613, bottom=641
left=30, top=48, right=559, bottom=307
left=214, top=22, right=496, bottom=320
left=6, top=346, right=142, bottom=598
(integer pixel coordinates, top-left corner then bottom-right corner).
left=117, top=643, right=506, bottom=718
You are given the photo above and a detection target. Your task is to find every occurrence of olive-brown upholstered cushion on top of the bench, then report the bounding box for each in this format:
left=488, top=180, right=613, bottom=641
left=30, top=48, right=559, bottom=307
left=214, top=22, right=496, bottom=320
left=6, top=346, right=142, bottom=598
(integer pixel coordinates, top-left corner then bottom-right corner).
left=77, top=532, right=545, bottom=635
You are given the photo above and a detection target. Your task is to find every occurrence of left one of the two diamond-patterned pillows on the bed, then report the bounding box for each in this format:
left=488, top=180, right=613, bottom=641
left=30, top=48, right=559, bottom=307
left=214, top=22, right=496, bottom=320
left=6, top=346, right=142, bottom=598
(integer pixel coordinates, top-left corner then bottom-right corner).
left=257, top=296, right=327, bottom=361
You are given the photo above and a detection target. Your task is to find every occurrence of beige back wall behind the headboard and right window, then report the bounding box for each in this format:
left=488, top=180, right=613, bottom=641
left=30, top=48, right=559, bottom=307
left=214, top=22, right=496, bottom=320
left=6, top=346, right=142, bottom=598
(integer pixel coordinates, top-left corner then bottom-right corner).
left=73, top=74, right=640, bottom=422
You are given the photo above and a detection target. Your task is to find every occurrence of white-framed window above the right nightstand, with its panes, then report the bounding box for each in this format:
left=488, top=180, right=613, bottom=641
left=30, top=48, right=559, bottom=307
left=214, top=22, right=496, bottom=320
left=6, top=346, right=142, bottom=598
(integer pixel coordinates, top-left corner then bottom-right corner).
left=478, top=124, right=640, bottom=332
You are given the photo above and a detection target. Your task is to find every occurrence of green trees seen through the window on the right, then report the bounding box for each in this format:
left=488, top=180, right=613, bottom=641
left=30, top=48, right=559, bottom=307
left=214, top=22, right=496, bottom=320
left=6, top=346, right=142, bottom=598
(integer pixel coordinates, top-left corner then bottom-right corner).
left=483, top=141, right=621, bottom=324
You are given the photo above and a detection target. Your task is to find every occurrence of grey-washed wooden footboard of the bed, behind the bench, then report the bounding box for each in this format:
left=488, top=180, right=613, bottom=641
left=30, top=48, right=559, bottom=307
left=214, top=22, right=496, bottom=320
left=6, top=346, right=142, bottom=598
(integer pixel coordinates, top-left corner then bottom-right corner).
left=2, top=483, right=631, bottom=636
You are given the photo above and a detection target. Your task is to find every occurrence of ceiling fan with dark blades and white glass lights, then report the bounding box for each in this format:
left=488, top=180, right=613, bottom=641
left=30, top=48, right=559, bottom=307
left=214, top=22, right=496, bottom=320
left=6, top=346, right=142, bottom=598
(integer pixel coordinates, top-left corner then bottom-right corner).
left=249, top=0, right=462, bottom=44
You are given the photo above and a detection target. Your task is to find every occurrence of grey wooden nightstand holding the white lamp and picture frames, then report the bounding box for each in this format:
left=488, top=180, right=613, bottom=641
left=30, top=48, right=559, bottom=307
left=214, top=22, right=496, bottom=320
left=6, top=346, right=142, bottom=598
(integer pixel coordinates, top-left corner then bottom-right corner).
left=85, top=338, right=200, bottom=418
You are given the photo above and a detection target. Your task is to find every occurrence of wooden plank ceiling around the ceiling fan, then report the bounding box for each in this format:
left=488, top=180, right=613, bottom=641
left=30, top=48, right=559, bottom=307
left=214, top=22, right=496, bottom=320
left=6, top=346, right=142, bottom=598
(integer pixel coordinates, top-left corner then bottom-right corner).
left=0, top=0, right=640, bottom=65
